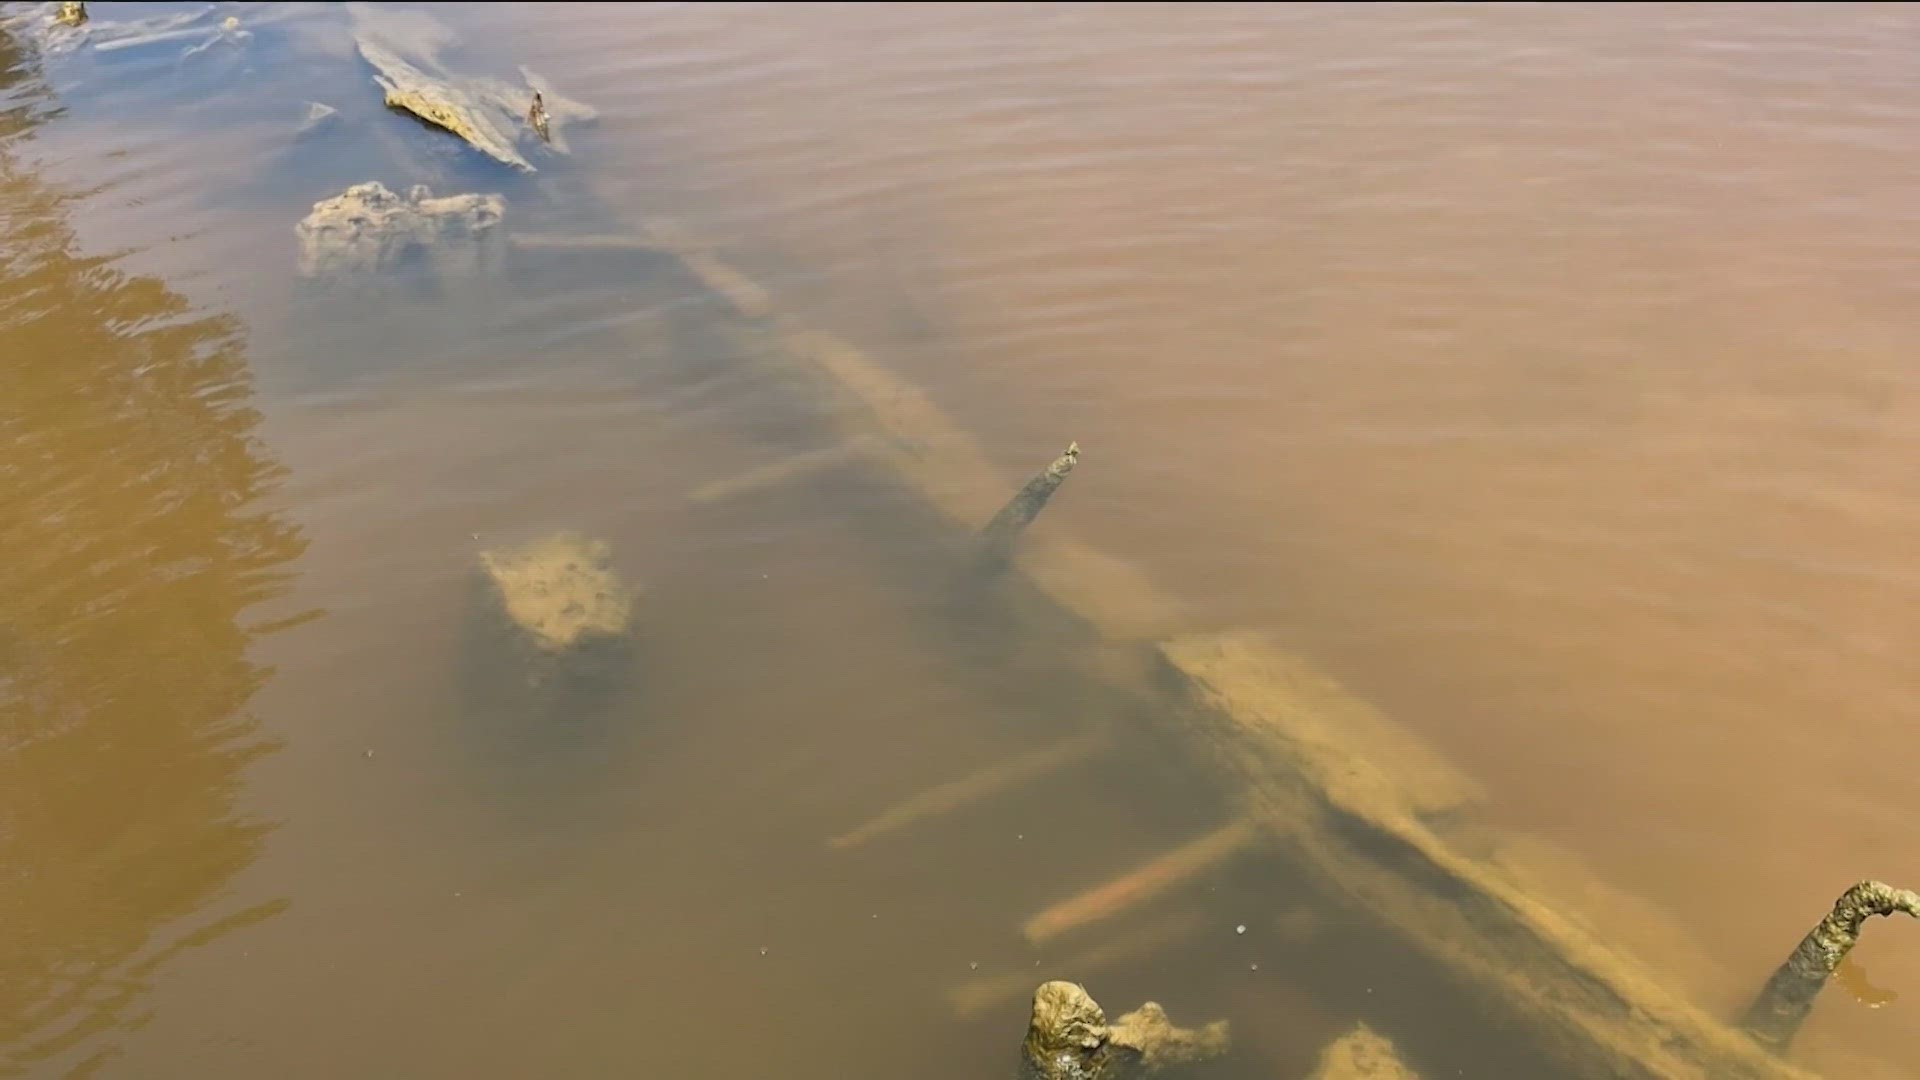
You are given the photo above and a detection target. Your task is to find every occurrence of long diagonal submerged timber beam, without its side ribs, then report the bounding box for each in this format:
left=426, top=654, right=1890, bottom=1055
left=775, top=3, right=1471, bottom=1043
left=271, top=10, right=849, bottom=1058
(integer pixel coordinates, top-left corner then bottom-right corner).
left=330, top=21, right=1889, bottom=1080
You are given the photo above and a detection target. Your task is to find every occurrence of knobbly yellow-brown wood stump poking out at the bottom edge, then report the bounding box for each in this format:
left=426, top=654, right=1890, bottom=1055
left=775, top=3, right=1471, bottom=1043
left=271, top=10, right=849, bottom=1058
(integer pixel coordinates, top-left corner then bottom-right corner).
left=1021, top=982, right=1229, bottom=1080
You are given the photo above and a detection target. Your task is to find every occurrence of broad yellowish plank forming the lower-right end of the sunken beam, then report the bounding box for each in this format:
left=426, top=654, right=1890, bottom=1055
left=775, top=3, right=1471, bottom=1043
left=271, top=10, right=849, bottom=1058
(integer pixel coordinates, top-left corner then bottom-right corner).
left=1162, top=634, right=1805, bottom=1080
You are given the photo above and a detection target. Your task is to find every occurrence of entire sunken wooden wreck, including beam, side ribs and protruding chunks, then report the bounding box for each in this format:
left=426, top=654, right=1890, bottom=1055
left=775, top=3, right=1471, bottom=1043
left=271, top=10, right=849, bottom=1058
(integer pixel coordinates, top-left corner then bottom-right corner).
left=18, top=4, right=1920, bottom=1080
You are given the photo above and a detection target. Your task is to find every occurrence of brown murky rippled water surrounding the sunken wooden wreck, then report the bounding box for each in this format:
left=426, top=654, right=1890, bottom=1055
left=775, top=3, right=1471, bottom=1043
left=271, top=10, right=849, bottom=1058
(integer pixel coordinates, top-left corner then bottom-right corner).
left=0, top=4, right=1920, bottom=1078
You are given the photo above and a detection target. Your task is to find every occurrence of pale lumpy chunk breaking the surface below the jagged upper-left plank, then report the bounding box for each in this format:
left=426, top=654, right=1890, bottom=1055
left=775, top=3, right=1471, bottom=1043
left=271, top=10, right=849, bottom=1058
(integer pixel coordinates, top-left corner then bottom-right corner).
left=294, top=181, right=507, bottom=277
